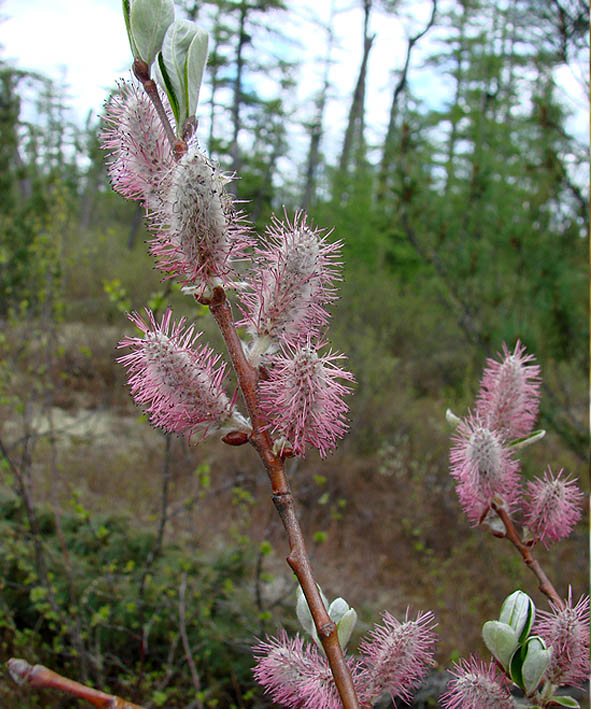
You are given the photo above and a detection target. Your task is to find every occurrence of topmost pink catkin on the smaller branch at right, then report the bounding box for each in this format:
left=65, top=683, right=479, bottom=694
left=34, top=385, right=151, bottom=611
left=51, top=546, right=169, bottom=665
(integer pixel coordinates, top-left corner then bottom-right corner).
left=476, top=341, right=540, bottom=440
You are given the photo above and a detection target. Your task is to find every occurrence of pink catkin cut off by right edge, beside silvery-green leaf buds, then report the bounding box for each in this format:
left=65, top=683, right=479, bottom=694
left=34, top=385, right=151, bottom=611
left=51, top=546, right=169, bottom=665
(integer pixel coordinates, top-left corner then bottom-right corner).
left=533, top=589, right=591, bottom=686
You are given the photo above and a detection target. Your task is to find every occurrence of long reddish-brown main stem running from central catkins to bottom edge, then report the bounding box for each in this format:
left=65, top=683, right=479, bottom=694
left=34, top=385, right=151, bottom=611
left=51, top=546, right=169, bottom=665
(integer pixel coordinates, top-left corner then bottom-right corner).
left=208, top=287, right=359, bottom=709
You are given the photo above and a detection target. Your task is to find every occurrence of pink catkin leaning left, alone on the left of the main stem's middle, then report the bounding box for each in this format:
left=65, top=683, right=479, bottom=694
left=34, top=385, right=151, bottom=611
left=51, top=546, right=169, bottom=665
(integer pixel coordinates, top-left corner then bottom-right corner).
left=117, top=309, right=232, bottom=436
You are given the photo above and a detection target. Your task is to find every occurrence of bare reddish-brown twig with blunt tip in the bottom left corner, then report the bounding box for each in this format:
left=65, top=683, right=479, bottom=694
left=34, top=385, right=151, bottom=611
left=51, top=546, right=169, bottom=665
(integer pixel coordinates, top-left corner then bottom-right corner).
left=8, top=657, right=142, bottom=709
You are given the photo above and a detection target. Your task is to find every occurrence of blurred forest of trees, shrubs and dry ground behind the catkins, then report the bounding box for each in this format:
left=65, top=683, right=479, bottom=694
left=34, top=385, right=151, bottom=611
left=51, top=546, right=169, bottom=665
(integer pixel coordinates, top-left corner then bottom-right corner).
left=0, top=0, right=589, bottom=708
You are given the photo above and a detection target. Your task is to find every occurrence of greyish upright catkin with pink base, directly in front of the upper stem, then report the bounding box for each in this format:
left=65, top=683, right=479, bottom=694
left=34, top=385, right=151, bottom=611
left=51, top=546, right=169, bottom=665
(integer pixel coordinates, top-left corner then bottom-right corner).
left=151, top=140, right=250, bottom=292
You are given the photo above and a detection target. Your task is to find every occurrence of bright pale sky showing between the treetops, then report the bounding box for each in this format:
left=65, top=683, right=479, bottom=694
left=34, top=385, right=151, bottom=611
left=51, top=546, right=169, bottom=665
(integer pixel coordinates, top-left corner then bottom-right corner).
left=0, top=0, right=588, bottom=166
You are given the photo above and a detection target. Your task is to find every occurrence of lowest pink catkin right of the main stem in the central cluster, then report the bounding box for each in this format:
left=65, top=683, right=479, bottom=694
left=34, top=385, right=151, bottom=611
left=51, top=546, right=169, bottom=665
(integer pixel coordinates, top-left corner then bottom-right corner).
left=259, top=343, right=354, bottom=457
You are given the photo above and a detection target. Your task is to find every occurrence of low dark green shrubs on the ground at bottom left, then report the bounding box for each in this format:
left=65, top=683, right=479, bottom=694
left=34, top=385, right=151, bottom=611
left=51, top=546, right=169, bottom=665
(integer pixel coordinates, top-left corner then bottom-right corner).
left=0, top=492, right=266, bottom=707
